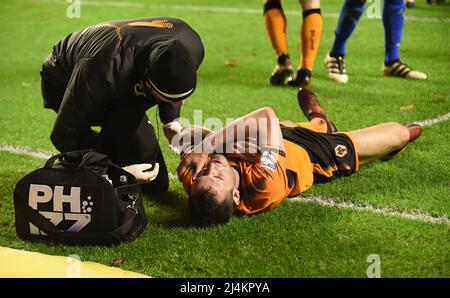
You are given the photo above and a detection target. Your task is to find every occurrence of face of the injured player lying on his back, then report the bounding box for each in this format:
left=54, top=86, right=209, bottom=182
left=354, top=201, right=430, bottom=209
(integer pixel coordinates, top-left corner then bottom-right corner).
left=191, top=154, right=237, bottom=201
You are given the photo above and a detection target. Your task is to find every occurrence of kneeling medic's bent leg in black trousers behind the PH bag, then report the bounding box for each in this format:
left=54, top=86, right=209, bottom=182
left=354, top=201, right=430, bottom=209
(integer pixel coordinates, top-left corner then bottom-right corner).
left=98, top=106, right=169, bottom=192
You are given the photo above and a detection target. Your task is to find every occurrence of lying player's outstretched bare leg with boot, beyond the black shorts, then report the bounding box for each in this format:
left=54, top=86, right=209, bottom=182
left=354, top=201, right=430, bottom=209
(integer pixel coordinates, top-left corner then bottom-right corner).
left=347, top=122, right=422, bottom=165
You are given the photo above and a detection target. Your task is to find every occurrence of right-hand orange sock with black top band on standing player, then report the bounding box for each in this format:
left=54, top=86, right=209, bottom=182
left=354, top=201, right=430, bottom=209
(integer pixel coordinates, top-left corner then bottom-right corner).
left=300, top=8, right=322, bottom=70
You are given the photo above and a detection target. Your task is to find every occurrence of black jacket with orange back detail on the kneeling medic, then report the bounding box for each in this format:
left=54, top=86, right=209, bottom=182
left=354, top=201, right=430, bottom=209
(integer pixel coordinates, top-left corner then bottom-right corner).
left=43, top=17, right=204, bottom=151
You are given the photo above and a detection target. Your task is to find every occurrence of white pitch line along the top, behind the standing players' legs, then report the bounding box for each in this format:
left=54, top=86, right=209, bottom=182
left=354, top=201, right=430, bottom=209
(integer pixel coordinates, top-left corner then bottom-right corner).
left=33, top=0, right=450, bottom=23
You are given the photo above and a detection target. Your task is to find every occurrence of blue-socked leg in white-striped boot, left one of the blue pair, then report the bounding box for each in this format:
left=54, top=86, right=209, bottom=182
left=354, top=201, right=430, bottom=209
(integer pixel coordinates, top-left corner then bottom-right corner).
left=324, top=0, right=365, bottom=83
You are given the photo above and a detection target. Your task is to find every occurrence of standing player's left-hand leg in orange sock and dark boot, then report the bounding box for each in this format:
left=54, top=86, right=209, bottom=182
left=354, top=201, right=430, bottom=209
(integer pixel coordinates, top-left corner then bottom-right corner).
left=264, top=0, right=292, bottom=85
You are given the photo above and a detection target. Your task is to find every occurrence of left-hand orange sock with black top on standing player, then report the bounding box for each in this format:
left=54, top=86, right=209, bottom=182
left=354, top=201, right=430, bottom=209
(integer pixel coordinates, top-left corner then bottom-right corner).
left=264, top=1, right=288, bottom=56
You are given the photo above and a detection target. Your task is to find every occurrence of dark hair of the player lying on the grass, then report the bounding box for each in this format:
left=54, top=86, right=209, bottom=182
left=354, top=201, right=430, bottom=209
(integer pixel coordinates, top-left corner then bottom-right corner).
left=189, top=186, right=235, bottom=227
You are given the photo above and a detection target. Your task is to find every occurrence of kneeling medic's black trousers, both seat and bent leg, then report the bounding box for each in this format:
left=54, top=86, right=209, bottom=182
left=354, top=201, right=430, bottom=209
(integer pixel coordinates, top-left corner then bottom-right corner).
left=41, top=59, right=170, bottom=193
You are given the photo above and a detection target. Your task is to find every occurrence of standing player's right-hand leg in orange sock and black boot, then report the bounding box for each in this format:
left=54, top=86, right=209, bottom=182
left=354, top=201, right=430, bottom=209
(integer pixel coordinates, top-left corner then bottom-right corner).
left=289, top=0, right=322, bottom=87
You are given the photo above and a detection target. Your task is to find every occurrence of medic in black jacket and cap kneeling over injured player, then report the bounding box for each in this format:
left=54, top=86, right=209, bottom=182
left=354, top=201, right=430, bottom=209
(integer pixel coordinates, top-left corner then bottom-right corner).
left=41, top=17, right=204, bottom=193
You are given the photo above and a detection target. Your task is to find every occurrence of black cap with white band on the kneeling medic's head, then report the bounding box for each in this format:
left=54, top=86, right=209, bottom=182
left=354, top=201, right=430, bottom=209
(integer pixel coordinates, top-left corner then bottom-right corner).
left=148, top=39, right=197, bottom=102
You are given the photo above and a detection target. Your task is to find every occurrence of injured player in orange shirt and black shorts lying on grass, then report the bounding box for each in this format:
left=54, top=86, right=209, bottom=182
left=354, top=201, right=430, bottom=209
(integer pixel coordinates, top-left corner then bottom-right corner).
left=172, top=89, right=422, bottom=226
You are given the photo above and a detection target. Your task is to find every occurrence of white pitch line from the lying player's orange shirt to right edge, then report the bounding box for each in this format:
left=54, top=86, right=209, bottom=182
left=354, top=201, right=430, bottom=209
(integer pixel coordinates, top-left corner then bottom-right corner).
left=287, top=197, right=450, bottom=224
